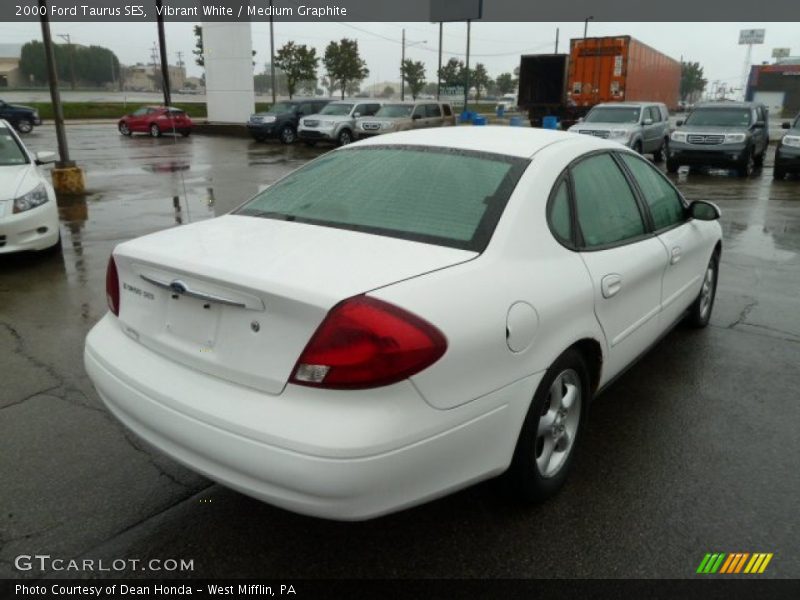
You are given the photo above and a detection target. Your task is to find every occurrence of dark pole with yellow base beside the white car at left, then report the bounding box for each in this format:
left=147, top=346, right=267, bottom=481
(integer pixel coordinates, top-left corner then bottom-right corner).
left=39, top=0, right=86, bottom=194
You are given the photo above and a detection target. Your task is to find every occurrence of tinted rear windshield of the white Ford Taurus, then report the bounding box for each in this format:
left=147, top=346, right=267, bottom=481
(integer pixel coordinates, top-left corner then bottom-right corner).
left=236, top=146, right=528, bottom=252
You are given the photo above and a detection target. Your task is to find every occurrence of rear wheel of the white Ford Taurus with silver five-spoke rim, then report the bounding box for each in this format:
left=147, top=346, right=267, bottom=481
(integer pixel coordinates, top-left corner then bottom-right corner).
left=506, top=348, right=591, bottom=502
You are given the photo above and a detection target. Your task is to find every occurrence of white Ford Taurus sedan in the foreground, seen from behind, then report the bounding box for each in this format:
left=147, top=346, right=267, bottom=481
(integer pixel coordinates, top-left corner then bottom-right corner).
left=85, top=127, right=721, bottom=520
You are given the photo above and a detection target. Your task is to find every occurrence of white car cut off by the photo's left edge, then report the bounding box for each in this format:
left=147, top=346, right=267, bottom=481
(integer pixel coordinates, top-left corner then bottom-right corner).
left=0, top=119, right=61, bottom=254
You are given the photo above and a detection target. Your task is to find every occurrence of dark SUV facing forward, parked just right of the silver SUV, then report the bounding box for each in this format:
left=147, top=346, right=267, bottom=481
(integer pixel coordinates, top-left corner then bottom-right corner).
left=667, top=102, right=769, bottom=177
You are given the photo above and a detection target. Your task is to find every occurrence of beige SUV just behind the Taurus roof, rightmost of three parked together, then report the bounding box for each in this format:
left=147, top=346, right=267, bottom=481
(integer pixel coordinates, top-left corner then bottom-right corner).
left=356, top=100, right=456, bottom=139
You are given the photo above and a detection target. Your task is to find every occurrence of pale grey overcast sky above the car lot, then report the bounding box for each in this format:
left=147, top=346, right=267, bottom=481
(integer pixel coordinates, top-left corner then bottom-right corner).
left=0, top=21, right=800, bottom=92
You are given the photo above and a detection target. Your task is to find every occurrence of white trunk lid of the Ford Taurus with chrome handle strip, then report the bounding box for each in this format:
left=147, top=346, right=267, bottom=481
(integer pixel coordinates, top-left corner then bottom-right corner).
left=114, top=215, right=476, bottom=394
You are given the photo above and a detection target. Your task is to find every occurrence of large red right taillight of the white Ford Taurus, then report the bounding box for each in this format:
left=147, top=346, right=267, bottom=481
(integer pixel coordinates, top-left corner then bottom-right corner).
left=291, top=296, right=447, bottom=389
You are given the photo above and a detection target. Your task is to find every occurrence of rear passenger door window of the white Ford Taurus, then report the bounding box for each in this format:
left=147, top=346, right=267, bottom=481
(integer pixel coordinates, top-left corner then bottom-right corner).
left=572, top=154, right=645, bottom=248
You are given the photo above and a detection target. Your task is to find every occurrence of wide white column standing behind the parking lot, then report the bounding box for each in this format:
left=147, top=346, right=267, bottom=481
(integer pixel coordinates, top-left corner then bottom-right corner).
left=202, top=23, right=255, bottom=123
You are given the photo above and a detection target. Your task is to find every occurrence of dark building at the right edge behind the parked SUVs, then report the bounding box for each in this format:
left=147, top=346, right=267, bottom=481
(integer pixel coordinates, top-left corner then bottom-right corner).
left=746, top=57, right=800, bottom=118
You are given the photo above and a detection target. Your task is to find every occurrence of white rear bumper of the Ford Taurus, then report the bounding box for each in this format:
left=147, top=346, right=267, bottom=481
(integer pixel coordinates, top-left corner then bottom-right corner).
left=84, top=315, right=540, bottom=520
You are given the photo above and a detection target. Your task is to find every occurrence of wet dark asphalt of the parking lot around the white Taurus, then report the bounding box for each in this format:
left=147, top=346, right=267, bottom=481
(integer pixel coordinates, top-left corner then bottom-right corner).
left=0, top=124, right=800, bottom=578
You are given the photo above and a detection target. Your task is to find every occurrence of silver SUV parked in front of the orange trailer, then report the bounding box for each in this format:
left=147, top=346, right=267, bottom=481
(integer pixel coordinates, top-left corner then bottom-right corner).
left=569, top=102, right=670, bottom=162
